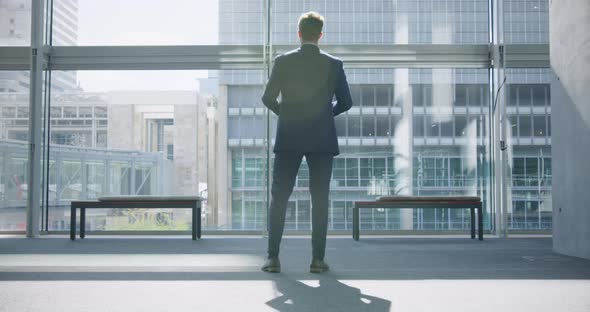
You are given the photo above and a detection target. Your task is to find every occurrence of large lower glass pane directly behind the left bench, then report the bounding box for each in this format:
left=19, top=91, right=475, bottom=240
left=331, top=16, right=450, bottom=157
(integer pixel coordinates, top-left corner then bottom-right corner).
left=45, top=70, right=266, bottom=230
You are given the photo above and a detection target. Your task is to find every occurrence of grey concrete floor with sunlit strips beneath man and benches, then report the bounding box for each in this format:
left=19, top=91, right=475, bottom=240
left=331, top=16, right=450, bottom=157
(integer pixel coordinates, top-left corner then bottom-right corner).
left=0, top=236, right=590, bottom=312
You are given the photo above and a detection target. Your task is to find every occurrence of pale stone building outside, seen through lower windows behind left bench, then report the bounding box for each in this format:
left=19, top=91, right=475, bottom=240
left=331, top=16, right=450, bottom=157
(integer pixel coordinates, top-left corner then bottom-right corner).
left=0, top=91, right=216, bottom=230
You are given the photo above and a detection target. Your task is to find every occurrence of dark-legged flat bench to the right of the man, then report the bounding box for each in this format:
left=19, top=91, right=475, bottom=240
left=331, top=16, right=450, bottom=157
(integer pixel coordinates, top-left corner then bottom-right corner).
left=352, top=196, right=483, bottom=241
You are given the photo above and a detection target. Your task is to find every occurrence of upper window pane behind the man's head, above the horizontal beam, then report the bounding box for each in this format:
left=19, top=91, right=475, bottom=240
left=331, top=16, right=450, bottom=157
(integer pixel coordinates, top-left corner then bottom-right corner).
left=270, top=0, right=488, bottom=44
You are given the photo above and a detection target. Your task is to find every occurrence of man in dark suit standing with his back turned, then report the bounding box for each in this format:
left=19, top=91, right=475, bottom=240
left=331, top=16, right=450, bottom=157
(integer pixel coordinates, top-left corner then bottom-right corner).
left=262, top=12, right=352, bottom=273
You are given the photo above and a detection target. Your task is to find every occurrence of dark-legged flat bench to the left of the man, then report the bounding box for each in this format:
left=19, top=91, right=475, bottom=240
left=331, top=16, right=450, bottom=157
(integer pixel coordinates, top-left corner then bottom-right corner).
left=70, top=195, right=202, bottom=240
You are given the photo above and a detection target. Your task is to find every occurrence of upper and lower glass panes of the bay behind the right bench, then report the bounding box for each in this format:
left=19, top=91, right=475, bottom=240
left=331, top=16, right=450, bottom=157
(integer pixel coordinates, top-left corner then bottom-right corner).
left=260, top=0, right=489, bottom=230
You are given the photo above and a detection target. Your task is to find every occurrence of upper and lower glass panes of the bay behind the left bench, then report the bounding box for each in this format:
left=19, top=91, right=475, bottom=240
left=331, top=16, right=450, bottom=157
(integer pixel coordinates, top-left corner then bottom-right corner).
left=46, top=0, right=266, bottom=231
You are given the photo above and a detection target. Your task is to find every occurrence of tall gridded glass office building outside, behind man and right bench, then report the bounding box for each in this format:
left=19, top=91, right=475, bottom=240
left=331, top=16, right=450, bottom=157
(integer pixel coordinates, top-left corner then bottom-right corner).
left=218, top=0, right=551, bottom=230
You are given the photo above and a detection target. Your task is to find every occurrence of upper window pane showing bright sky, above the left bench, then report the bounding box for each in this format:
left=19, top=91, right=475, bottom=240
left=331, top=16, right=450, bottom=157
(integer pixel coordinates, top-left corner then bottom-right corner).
left=52, top=0, right=266, bottom=46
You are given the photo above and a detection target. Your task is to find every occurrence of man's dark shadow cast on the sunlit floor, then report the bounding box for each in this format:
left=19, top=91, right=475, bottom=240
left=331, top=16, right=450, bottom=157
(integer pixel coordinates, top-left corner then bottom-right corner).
left=266, top=273, right=391, bottom=312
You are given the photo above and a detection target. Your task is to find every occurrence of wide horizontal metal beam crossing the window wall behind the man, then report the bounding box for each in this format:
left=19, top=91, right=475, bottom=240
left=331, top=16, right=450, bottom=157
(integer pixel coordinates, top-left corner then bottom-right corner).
left=0, top=44, right=549, bottom=70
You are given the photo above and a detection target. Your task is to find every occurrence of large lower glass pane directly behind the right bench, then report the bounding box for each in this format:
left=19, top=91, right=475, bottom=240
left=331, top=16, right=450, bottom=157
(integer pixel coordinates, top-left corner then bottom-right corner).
left=324, top=69, right=489, bottom=230
